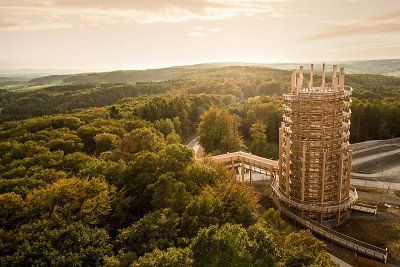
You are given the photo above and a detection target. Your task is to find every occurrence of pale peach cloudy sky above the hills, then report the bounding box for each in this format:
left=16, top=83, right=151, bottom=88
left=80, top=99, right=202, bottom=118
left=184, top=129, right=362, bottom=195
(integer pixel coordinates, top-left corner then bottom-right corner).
left=0, top=0, right=400, bottom=70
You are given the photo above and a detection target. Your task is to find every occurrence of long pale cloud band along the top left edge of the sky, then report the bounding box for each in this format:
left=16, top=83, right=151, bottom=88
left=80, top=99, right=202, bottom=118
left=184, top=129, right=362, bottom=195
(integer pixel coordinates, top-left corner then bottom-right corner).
left=0, top=0, right=282, bottom=30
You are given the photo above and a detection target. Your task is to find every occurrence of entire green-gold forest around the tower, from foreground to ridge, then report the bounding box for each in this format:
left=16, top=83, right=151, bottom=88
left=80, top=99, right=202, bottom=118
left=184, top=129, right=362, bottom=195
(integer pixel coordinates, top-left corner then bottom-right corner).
left=0, top=66, right=400, bottom=266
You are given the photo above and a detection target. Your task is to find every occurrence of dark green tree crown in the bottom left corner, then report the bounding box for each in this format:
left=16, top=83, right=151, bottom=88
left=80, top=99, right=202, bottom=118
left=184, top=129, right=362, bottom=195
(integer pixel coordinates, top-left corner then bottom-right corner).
left=0, top=221, right=112, bottom=266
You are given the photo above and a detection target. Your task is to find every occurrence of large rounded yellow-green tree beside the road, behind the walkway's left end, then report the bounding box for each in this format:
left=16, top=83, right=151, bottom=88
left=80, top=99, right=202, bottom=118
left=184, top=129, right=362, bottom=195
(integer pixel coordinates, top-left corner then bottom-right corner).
left=197, top=107, right=243, bottom=154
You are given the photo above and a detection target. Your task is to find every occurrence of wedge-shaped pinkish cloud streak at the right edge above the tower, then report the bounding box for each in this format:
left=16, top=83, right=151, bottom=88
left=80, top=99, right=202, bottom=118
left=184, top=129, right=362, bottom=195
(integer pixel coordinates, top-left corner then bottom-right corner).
left=300, top=10, right=400, bottom=41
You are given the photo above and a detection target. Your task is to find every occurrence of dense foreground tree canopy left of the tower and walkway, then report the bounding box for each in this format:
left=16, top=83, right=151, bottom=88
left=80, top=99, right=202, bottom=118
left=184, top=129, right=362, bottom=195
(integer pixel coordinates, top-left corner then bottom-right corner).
left=0, top=104, right=333, bottom=266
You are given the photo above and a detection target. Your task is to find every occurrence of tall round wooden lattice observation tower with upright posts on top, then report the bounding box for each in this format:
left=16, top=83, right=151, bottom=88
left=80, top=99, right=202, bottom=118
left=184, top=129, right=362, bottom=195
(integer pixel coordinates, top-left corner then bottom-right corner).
left=273, top=64, right=357, bottom=224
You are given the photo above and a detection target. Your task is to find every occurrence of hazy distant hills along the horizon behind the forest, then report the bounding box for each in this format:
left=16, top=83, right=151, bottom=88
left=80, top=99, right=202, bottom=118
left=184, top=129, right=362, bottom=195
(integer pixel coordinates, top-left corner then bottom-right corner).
left=0, top=59, right=400, bottom=91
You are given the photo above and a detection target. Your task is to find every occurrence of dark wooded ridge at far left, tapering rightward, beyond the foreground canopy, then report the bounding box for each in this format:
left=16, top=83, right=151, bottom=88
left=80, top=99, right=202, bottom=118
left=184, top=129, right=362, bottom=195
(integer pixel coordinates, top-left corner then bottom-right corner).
left=0, top=82, right=176, bottom=118
